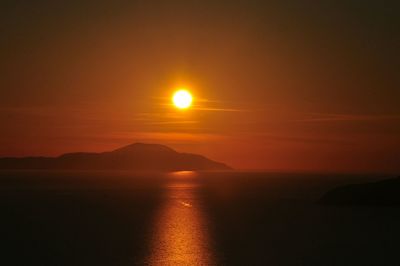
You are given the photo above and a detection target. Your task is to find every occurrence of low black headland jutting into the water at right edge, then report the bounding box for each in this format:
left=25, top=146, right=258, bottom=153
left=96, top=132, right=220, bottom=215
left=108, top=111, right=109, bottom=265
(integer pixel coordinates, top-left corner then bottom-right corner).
left=319, top=177, right=400, bottom=206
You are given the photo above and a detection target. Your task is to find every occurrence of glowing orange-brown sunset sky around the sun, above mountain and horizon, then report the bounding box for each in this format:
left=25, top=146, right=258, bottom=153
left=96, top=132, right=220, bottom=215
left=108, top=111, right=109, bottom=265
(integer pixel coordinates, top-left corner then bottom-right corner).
left=0, top=0, right=400, bottom=173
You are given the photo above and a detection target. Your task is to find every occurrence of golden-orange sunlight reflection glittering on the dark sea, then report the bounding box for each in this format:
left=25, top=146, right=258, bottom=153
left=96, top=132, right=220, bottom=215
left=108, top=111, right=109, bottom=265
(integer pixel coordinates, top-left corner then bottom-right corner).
left=147, top=171, right=216, bottom=265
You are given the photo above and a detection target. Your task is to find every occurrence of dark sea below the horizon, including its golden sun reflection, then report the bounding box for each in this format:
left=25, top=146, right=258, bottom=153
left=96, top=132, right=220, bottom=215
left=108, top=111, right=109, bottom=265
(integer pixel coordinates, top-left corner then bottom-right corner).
left=0, top=172, right=400, bottom=266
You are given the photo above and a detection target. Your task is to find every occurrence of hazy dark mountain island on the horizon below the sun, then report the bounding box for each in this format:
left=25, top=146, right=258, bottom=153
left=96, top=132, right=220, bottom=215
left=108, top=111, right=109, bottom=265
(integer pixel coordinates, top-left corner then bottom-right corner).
left=0, top=143, right=231, bottom=171
